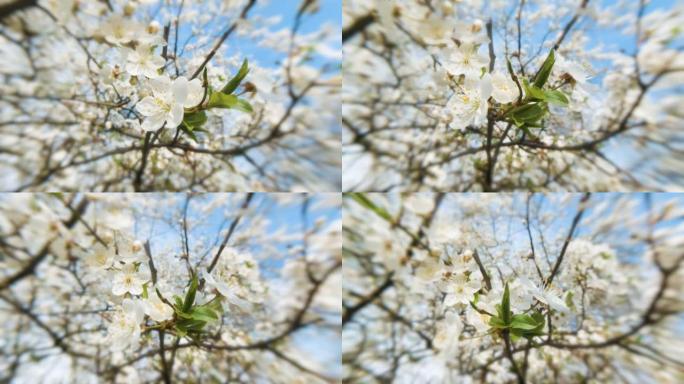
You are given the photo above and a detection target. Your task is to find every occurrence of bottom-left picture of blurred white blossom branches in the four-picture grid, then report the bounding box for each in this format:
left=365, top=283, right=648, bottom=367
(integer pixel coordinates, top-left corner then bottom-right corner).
left=0, top=194, right=342, bottom=383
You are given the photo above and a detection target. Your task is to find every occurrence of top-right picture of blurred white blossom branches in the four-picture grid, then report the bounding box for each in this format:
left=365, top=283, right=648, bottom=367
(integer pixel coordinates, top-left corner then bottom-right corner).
left=342, top=0, right=684, bottom=192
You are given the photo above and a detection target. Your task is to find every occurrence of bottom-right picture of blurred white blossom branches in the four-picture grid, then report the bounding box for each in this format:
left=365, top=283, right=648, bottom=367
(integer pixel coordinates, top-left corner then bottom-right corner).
left=342, top=193, right=684, bottom=383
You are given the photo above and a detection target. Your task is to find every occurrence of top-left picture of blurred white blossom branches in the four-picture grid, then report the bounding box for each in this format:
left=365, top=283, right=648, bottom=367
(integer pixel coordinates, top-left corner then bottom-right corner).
left=0, top=0, right=342, bottom=192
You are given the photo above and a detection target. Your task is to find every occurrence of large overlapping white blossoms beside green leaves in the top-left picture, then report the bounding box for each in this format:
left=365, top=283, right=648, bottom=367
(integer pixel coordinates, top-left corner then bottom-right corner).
left=136, top=76, right=204, bottom=131
